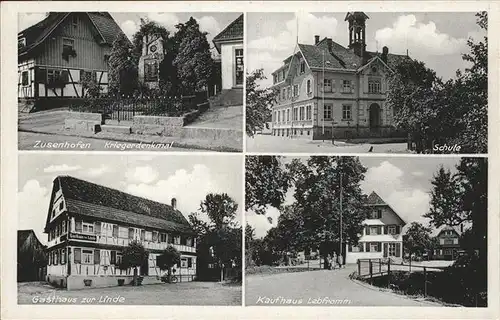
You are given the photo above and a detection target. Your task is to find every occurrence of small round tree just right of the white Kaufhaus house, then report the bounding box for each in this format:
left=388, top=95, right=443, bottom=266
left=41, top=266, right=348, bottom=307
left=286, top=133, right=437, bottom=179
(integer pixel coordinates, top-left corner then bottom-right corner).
left=403, top=222, right=434, bottom=257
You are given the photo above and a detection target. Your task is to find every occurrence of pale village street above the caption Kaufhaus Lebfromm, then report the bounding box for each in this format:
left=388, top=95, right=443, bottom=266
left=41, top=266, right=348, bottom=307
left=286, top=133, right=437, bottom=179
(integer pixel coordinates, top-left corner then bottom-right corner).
left=245, top=265, right=440, bottom=306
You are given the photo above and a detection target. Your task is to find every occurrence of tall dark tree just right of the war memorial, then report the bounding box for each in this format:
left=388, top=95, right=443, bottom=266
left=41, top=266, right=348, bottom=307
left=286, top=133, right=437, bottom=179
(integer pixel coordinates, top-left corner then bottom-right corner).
left=173, top=17, right=214, bottom=93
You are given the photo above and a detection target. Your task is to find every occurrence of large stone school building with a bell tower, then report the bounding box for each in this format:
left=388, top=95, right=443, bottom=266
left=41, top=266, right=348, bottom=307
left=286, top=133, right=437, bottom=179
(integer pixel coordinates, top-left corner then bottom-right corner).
left=272, top=12, right=410, bottom=139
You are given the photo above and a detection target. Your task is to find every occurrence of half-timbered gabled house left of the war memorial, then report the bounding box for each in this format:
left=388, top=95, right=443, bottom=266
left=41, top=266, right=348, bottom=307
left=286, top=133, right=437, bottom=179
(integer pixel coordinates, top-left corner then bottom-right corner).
left=17, top=12, right=127, bottom=111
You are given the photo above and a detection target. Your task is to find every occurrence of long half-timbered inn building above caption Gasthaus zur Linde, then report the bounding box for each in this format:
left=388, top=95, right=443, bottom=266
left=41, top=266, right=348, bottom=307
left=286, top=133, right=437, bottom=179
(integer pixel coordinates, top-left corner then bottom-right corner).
left=44, top=176, right=196, bottom=289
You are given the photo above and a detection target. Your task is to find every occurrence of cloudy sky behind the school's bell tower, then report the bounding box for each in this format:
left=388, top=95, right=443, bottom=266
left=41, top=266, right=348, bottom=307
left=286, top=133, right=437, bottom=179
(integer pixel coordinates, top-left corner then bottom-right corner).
left=247, top=12, right=485, bottom=86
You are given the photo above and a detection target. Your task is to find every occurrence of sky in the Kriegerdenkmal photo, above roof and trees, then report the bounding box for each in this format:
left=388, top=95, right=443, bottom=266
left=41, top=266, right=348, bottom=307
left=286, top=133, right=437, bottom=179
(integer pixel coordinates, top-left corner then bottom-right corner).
left=18, top=12, right=241, bottom=54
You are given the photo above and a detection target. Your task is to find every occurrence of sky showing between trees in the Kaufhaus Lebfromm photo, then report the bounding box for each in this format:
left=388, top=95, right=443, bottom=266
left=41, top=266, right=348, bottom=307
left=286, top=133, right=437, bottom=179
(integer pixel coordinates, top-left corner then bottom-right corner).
left=245, top=157, right=460, bottom=238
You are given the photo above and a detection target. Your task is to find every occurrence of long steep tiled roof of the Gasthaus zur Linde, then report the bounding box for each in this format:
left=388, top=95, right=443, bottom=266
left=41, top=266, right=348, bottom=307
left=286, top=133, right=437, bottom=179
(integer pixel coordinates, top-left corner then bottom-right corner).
left=49, top=176, right=193, bottom=233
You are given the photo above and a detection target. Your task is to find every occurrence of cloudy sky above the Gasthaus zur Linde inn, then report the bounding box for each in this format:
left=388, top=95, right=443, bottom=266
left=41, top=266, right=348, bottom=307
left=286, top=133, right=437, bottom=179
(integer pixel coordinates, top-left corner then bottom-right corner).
left=17, top=153, right=243, bottom=244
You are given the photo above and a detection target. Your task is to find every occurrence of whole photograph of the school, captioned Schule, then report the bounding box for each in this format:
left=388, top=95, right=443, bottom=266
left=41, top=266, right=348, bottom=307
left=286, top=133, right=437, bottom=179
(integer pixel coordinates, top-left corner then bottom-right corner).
left=245, top=12, right=488, bottom=154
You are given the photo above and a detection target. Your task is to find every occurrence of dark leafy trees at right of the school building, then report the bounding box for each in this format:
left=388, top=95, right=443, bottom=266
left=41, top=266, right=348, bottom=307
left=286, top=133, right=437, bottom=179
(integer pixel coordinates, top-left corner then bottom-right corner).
left=387, top=12, right=488, bottom=153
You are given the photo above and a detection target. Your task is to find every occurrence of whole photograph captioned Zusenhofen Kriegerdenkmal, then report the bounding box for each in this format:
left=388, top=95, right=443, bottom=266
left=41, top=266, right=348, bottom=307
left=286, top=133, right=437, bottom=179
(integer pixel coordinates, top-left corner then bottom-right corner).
left=17, top=12, right=244, bottom=152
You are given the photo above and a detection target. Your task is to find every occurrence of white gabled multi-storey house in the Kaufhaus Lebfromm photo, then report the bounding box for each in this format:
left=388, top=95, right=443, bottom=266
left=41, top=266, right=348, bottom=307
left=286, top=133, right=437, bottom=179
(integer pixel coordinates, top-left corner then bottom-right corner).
left=346, top=192, right=406, bottom=263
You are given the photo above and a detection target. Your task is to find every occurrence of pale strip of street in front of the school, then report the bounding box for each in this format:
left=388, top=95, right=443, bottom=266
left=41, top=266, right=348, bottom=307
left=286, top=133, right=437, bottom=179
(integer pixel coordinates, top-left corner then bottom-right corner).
left=246, top=134, right=409, bottom=153
